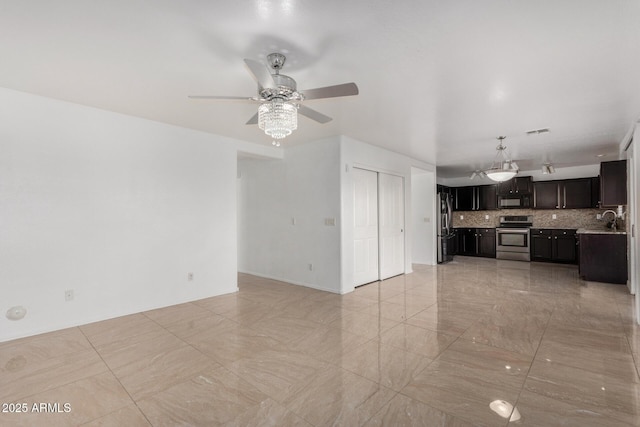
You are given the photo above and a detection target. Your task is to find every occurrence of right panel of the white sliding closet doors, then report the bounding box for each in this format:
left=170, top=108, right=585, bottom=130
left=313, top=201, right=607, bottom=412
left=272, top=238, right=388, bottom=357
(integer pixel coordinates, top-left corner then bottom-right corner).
left=378, top=173, right=404, bottom=280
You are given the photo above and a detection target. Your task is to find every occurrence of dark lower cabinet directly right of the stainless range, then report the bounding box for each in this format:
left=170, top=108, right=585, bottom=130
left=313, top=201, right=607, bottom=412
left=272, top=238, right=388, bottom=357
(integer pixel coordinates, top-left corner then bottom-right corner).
left=531, top=228, right=578, bottom=264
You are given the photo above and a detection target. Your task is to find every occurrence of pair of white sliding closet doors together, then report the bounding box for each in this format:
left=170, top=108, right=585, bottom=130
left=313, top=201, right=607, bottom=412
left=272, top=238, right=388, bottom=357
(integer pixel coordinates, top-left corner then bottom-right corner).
left=353, top=168, right=405, bottom=286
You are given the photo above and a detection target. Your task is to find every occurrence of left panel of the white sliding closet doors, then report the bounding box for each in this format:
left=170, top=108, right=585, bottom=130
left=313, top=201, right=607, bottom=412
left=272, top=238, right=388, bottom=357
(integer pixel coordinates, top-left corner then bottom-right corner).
left=353, top=168, right=379, bottom=286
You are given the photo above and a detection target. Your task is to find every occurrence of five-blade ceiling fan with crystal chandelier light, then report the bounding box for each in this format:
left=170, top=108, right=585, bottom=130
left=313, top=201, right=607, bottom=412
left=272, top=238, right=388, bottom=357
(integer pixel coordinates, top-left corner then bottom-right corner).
left=189, top=53, right=358, bottom=146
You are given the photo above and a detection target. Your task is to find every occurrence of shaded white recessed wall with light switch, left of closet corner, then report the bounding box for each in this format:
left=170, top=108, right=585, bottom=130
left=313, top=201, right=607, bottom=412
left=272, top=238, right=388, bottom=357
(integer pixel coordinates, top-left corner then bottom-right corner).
left=238, top=139, right=341, bottom=292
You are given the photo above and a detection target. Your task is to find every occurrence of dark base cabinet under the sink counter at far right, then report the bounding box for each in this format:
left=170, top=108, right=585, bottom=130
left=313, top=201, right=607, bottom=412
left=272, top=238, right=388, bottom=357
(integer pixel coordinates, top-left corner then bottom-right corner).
left=578, top=233, right=628, bottom=284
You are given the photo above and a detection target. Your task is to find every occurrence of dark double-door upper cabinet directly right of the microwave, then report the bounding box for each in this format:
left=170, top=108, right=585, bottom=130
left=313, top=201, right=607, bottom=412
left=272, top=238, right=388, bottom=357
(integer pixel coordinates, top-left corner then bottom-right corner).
left=533, top=178, right=594, bottom=209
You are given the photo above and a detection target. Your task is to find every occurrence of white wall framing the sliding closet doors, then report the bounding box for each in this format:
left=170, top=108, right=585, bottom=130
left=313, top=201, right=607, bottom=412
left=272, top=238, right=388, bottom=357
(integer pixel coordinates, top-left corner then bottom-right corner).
left=340, top=136, right=435, bottom=293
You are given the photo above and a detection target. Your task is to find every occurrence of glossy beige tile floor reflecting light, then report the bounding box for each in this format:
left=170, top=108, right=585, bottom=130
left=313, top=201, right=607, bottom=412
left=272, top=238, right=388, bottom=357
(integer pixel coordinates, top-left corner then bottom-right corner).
left=0, top=257, right=640, bottom=427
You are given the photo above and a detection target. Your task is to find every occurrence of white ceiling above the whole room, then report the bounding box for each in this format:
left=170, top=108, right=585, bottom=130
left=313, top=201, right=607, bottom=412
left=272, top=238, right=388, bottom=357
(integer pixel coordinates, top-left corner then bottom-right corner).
left=0, top=0, right=640, bottom=177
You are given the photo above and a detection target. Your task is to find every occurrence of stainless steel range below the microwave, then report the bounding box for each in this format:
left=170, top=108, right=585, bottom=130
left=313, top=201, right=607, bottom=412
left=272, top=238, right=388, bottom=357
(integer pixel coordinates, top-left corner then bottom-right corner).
left=496, top=215, right=533, bottom=261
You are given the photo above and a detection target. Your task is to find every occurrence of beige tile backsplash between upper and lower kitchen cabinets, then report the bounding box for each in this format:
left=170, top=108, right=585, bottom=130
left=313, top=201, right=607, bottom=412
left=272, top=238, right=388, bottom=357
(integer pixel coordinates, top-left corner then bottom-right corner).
left=452, top=209, right=626, bottom=229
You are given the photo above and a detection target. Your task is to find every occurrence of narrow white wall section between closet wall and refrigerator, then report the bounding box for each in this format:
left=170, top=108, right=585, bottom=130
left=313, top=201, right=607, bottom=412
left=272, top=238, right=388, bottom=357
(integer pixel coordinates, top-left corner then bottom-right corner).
left=411, top=168, right=437, bottom=265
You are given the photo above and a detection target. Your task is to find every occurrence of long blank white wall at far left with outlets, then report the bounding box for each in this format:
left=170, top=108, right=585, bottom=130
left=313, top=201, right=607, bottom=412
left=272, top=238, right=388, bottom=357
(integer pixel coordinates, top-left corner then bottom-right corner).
left=0, top=89, right=237, bottom=341
